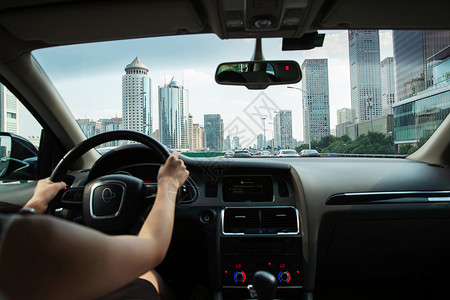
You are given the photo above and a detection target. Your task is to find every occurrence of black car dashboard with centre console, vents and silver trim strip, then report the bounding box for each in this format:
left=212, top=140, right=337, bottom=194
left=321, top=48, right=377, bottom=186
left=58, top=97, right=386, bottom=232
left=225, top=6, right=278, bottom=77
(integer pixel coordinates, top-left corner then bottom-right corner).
left=61, top=146, right=450, bottom=299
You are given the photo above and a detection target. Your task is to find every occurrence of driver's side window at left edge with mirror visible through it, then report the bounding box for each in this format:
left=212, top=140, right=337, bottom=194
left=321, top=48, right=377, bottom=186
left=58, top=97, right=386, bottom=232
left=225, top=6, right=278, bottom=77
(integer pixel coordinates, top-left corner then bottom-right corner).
left=0, top=83, right=42, bottom=184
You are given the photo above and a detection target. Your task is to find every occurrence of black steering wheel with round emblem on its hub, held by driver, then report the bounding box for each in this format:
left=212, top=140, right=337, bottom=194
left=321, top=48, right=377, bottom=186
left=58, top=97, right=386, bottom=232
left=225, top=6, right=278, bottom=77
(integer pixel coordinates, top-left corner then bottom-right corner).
left=49, top=130, right=170, bottom=232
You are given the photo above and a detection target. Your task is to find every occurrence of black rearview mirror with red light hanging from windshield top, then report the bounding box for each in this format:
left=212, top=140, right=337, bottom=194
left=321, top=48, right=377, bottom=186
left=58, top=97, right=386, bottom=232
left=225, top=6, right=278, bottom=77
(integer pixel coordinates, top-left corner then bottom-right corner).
left=215, top=60, right=302, bottom=90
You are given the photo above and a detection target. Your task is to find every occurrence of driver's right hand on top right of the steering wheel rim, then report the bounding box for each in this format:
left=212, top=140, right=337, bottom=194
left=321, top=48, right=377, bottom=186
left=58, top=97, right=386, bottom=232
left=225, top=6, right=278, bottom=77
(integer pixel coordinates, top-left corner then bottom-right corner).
left=158, top=152, right=189, bottom=192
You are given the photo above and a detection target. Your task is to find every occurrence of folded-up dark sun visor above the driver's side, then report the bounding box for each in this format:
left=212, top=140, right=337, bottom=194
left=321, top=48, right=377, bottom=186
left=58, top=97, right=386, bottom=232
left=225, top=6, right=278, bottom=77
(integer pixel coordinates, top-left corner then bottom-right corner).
left=0, top=0, right=204, bottom=44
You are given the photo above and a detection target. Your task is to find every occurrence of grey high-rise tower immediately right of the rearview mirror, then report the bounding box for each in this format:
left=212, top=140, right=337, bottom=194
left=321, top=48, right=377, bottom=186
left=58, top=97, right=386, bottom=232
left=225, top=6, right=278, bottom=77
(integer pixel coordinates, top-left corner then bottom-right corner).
left=302, top=59, right=330, bottom=143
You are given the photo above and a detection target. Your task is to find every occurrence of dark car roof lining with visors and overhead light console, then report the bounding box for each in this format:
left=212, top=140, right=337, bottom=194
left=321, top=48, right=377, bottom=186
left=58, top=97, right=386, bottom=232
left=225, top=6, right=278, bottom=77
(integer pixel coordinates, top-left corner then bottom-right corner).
left=0, top=0, right=450, bottom=62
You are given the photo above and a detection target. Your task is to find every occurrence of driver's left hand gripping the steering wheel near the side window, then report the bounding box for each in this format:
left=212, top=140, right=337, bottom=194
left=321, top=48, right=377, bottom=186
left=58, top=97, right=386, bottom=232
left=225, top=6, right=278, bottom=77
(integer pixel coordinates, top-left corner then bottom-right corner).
left=24, top=178, right=66, bottom=214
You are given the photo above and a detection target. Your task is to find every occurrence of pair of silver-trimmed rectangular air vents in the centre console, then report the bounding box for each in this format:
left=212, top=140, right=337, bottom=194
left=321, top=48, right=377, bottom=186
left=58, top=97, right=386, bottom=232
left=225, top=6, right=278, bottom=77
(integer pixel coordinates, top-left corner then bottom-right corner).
left=223, top=207, right=299, bottom=234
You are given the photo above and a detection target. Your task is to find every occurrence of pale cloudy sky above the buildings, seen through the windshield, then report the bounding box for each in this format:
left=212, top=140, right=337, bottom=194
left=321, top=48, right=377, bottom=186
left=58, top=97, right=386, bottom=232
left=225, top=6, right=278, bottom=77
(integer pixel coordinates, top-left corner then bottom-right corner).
left=33, top=31, right=392, bottom=140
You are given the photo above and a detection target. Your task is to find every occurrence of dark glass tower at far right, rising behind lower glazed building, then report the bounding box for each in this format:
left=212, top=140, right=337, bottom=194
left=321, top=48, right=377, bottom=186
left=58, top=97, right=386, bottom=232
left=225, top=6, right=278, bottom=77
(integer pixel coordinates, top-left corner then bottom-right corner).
left=392, top=30, right=450, bottom=101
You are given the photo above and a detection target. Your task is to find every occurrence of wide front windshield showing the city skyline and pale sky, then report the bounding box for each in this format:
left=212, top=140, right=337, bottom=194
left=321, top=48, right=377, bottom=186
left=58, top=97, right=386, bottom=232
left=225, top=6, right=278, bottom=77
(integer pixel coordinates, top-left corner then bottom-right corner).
left=33, top=30, right=450, bottom=156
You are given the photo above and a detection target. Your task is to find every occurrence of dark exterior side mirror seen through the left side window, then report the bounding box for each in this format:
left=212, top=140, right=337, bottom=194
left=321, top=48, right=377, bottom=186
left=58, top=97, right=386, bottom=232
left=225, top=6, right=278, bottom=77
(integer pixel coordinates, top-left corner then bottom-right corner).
left=0, top=132, right=38, bottom=181
